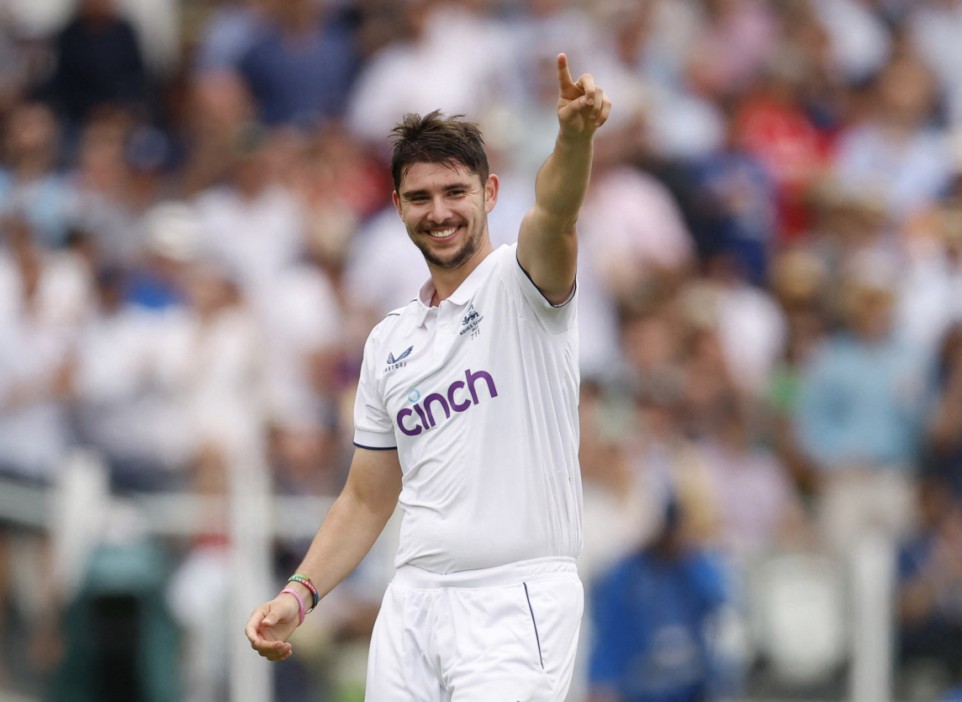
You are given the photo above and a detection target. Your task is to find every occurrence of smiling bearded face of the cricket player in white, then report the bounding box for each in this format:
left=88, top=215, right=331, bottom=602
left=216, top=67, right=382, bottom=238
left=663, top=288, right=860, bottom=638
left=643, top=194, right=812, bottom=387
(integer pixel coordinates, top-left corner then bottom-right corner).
left=393, top=162, right=498, bottom=277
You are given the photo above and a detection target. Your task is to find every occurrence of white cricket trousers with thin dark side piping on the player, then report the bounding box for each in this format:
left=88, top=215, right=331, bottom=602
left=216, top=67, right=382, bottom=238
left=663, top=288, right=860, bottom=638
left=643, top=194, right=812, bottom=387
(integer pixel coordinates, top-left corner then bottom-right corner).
left=365, top=558, right=584, bottom=702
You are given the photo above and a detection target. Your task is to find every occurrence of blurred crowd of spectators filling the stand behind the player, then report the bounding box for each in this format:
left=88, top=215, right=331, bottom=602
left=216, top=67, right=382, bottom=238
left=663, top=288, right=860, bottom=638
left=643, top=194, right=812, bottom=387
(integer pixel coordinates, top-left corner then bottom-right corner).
left=0, top=0, right=962, bottom=702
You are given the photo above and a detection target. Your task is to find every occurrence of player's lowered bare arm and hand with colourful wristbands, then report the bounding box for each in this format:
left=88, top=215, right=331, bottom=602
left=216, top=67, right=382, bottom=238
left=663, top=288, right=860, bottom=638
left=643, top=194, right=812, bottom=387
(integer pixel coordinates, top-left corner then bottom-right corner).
left=245, top=448, right=401, bottom=661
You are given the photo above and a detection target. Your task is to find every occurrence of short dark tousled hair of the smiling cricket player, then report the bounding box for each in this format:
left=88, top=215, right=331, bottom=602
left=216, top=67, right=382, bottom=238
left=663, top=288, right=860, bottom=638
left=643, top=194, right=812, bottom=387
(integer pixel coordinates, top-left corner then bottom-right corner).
left=391, top=110, right=489, bottom=190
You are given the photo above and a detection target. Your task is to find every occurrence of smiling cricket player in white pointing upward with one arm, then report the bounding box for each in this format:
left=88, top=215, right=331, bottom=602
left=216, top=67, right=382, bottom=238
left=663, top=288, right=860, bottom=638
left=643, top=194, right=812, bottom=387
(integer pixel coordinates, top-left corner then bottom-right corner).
left=246, top=54, right=611, bottom=702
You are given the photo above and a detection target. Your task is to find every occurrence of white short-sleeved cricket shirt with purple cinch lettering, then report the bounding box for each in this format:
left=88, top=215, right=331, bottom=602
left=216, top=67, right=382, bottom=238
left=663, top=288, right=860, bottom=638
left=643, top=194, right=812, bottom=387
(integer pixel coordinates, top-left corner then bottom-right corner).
left=354, top=245, right=582, bottom=574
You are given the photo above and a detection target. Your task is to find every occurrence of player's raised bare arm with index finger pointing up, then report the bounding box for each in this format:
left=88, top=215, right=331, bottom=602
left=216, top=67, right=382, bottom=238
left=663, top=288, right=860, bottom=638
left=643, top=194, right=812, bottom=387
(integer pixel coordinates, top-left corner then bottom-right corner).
left=518, top=54, right=611, bottom=304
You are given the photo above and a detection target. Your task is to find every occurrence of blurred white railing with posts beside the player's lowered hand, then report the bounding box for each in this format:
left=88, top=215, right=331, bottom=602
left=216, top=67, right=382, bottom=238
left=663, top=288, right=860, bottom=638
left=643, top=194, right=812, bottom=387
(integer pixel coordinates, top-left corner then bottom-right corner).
left=0, top=451, right=332, bottom=702
